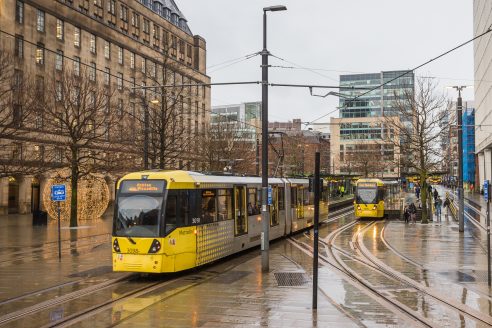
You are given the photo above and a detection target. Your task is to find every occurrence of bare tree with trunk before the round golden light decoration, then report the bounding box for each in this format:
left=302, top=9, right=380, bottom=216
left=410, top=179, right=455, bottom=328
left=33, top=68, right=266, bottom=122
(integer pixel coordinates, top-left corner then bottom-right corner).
left=43, top=70, right=123, bottom=227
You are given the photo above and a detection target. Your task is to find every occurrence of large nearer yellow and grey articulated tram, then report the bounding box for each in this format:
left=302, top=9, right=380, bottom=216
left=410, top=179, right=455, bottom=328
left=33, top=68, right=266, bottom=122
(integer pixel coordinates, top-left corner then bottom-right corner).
left=112, top=171, right=328, bottom=273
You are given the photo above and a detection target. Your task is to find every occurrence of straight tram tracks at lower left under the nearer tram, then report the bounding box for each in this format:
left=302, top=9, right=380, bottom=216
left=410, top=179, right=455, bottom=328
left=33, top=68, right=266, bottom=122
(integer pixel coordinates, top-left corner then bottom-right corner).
left=0, top=206, right=351, bottom=327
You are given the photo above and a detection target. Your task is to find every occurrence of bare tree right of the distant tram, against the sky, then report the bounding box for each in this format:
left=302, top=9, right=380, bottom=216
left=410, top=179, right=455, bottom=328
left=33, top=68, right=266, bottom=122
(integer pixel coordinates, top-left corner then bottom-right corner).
left=384, top=78, right=448, bottom=223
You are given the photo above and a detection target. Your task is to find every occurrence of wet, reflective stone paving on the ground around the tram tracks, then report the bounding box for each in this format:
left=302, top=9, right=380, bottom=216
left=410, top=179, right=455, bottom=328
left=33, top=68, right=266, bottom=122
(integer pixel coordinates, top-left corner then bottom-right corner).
left=0, top=191, right=490, bottom=327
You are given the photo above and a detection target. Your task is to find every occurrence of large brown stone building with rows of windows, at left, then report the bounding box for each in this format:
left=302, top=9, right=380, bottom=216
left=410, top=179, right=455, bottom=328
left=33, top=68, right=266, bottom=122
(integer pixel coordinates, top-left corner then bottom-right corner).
left=0, top=0, right=210, bottom=214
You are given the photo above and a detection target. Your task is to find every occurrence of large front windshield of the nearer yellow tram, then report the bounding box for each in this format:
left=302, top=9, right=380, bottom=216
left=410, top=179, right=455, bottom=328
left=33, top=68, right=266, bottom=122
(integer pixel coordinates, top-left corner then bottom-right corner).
left=114, top=195, right=163, bottom=237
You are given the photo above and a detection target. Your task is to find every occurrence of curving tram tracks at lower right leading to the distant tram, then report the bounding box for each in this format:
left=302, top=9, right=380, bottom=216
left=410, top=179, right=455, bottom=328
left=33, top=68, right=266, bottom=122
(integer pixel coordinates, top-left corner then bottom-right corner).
left=290, top=221, right=492, bottom=327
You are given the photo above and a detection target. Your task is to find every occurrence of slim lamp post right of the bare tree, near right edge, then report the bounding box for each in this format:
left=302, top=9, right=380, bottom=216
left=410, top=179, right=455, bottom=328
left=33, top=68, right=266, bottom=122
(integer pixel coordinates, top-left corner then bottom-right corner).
left=452, top=85, right=466, bottom=232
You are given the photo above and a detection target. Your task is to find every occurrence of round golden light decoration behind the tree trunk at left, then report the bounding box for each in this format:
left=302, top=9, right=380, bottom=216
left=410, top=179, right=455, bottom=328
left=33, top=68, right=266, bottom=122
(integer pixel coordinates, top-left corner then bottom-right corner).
left=43, top=174, right=109, bottom=220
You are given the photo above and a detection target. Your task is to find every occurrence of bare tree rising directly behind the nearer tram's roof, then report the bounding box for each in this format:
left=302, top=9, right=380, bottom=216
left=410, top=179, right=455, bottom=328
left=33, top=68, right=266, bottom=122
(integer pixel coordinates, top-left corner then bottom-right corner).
left=132, top=37, right=204, bottom=169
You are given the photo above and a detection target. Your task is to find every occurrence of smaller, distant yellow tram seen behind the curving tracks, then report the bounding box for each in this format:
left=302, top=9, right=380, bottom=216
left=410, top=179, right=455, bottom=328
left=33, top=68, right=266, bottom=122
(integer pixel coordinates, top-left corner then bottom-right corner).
left=354, top=179, right=400, bottom=218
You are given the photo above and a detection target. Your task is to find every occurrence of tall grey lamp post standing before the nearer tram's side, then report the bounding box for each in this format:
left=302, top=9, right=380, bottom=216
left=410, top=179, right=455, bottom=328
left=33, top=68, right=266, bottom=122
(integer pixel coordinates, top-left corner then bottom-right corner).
left=261, top=6, right=287, bottom=272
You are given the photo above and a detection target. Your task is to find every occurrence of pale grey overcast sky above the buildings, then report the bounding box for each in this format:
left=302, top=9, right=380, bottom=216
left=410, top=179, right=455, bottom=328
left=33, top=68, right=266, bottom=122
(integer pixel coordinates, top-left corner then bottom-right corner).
left=179, top=0, right=473, bottom=128
